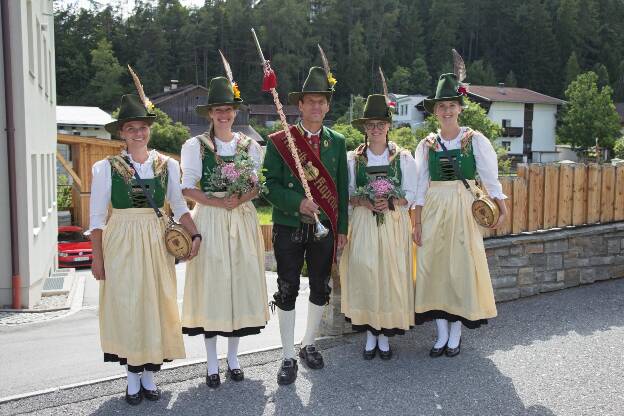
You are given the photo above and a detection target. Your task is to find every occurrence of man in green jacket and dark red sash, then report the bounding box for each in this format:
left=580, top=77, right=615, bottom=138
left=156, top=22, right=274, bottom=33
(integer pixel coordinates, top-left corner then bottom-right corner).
left=264, top=67, right=349, bottom=384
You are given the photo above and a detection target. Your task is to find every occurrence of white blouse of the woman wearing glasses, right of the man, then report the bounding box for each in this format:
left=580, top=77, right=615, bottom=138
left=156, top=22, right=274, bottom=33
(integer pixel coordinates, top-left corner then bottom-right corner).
left=347, top=148, right=417, bottom=209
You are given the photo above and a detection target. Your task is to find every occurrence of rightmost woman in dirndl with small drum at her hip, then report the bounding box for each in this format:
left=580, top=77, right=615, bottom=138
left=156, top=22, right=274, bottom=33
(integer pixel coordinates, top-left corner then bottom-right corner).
left=413, top=73, right=507, bottom=357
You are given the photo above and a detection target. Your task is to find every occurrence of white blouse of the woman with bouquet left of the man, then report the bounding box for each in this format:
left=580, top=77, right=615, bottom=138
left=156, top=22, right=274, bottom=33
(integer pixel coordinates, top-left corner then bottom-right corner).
left=181, top=133, right=264, bottom=189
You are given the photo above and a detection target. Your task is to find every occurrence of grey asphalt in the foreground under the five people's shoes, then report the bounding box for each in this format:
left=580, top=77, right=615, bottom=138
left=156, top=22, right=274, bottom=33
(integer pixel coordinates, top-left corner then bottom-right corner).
left=0, top=279, right=624, bottom=416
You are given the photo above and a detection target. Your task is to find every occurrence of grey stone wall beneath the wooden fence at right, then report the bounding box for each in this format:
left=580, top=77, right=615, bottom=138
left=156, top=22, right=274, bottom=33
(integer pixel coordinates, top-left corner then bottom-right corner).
left=485, top=222, right=624, bottom=302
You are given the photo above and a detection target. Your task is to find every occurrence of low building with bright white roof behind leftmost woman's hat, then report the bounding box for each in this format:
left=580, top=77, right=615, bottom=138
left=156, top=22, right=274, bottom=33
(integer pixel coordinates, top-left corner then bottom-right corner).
left=56, top=105, right=114, bottom=140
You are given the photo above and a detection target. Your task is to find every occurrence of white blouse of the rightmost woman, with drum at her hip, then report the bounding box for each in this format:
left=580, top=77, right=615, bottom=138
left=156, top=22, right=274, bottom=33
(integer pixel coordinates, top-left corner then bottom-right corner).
left=414, top=127, right=507, bottom=206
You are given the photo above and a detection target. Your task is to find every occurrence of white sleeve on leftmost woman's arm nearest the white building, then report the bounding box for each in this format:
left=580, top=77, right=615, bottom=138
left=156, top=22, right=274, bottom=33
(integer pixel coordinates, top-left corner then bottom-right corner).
left=85, top=159, right=112, bottom=235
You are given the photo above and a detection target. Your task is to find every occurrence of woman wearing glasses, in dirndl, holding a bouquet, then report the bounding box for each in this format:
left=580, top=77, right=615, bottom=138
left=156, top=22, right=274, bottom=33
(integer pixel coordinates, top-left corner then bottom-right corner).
left=340, top=94, right=416, bottom=360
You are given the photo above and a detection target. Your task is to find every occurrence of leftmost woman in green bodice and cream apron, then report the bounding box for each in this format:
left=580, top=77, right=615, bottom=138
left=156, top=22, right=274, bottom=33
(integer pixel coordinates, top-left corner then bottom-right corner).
left=89, top=95, right=200, bottom=405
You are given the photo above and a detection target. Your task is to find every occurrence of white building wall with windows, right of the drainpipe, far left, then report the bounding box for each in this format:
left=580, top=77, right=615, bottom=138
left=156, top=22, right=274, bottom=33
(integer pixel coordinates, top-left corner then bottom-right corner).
left=0, top=0, right=58, bottom=307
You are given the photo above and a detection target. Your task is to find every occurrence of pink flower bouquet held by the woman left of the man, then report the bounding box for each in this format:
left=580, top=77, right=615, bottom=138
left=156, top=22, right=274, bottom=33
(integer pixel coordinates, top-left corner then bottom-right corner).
left=208, top=155, right=265, bottom=197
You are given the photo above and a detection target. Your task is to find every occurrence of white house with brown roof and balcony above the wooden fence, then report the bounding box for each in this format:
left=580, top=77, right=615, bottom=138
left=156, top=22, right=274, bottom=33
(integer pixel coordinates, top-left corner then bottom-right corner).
left=468, top=84, right=565, bottom=162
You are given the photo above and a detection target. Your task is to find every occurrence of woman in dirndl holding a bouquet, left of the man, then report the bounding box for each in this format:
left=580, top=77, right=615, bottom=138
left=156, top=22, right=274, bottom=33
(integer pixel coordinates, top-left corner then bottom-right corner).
left=182, top=77, right=269, bottom=388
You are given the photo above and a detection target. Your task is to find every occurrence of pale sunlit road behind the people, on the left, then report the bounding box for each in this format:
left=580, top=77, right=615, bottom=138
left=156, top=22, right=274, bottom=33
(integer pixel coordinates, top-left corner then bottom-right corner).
left=0, top=263, right=309, bottom=398
